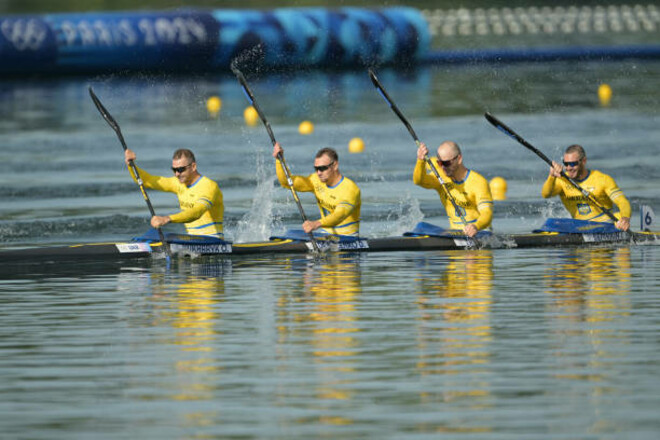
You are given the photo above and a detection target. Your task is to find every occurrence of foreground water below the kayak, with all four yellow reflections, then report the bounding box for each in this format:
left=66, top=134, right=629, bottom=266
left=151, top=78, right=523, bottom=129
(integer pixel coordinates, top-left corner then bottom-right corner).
left=0, top=246, right=660, bottom=439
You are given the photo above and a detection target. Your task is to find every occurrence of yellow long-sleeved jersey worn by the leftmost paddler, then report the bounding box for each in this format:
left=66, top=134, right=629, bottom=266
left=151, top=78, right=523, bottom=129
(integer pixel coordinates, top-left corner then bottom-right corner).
left=129, top=168, right=224, bottom=238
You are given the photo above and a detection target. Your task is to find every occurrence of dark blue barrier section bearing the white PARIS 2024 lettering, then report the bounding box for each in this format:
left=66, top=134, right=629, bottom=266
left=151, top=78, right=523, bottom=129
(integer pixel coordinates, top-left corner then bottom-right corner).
left=46, top=11, right=218, bottom=72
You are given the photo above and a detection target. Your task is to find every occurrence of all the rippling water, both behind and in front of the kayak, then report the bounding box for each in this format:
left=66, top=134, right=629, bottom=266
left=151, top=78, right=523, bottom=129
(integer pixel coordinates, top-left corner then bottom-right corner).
left=0, top=61, right=660, bottom=439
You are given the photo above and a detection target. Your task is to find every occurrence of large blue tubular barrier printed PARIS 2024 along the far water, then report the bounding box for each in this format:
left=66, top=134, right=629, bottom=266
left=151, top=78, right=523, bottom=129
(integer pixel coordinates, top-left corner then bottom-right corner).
left=0, top=7, right=430, bottom=75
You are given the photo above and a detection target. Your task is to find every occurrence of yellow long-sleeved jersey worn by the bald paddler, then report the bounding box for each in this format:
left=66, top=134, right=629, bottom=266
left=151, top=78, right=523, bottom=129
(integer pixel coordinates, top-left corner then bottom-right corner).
left=413, top=157, right=493, bottom=230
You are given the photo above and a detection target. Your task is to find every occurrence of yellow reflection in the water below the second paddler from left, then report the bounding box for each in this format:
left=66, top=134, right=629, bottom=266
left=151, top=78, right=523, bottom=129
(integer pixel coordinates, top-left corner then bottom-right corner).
left=278, top=254, right=362, bottom=425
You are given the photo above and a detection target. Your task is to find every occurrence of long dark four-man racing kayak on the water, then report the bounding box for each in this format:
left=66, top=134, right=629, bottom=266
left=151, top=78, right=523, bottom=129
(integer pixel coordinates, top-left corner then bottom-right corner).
left=0, top=231, right=660, bottom=265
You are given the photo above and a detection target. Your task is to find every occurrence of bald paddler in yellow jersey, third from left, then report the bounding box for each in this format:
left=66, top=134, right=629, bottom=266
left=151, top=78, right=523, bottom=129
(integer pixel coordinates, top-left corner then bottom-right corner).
left=413, top=141, right=493, bottom=237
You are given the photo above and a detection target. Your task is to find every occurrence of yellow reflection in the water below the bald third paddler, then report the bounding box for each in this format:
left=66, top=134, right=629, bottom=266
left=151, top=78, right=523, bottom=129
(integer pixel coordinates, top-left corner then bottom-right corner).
left=415, top=250, right=493, bottom=432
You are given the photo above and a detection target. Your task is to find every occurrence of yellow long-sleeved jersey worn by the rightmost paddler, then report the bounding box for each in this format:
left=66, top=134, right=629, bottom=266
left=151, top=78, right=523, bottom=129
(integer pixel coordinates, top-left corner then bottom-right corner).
left=541, top=170, right=631, bottom=222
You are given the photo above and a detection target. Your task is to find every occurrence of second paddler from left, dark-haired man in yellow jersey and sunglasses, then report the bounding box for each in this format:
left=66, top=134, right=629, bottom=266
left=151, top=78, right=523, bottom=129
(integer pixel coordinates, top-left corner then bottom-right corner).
left=273, top=143, right=362, bottom=236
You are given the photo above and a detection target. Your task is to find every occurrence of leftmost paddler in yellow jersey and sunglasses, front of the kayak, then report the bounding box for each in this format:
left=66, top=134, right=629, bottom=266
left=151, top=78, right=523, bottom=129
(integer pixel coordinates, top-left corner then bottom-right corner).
left=124, top=149, right=224, bottom=238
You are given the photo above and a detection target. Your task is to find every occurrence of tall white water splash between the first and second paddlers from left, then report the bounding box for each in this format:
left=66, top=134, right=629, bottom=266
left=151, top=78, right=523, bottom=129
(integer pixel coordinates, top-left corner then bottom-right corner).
left=234, top=152, right=275, bottom=243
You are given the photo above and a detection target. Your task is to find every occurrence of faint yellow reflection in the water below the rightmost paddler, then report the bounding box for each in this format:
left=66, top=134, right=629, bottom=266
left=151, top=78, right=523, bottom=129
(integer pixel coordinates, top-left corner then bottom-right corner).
left=544, top=247, right=632, bottom=388
